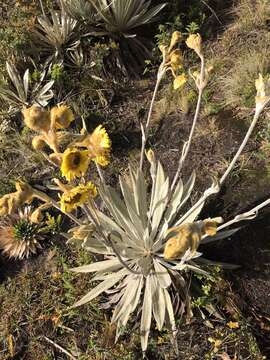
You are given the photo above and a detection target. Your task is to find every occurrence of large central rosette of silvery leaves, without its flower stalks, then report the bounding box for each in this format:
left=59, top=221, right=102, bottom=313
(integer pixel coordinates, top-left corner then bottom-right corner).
left=68, top=152, right=243, bottom=351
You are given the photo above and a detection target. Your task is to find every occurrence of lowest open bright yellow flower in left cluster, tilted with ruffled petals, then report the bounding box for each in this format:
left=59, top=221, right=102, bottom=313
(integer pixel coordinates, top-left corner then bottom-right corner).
left=60, top=182, right=97, bottom=213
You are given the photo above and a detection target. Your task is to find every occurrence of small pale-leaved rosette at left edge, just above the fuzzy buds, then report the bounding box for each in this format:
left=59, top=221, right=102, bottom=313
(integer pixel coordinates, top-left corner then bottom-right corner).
left=0, top=62, right=54, bottom=112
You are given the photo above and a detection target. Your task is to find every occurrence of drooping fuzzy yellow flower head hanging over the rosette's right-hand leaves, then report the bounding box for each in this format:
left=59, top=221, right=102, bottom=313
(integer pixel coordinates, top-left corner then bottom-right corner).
left=164, top=218, right=222, bottom=260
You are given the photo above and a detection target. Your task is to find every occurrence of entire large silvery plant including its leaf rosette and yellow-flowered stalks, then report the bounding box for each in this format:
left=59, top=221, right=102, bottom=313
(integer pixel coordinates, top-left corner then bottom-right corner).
left=0, top=31, right=270, bottom=358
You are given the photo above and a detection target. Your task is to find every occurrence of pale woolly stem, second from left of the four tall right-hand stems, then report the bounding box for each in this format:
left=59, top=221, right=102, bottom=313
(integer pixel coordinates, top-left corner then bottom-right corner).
left=171, top=55, right=205, bottom=191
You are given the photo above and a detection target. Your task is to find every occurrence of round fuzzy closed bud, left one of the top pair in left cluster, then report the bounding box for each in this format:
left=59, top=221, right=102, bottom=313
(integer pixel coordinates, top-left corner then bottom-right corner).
left=22, top=105, right=51, bottom=132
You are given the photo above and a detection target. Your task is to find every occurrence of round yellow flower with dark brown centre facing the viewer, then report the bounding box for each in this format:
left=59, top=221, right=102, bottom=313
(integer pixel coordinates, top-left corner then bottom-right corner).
left=61, top=149, right=90, bottom=181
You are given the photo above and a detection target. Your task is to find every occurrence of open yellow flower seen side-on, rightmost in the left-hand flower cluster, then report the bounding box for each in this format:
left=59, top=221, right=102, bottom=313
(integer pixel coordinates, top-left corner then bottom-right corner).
left=75, top=125, right=112, bottom=166
